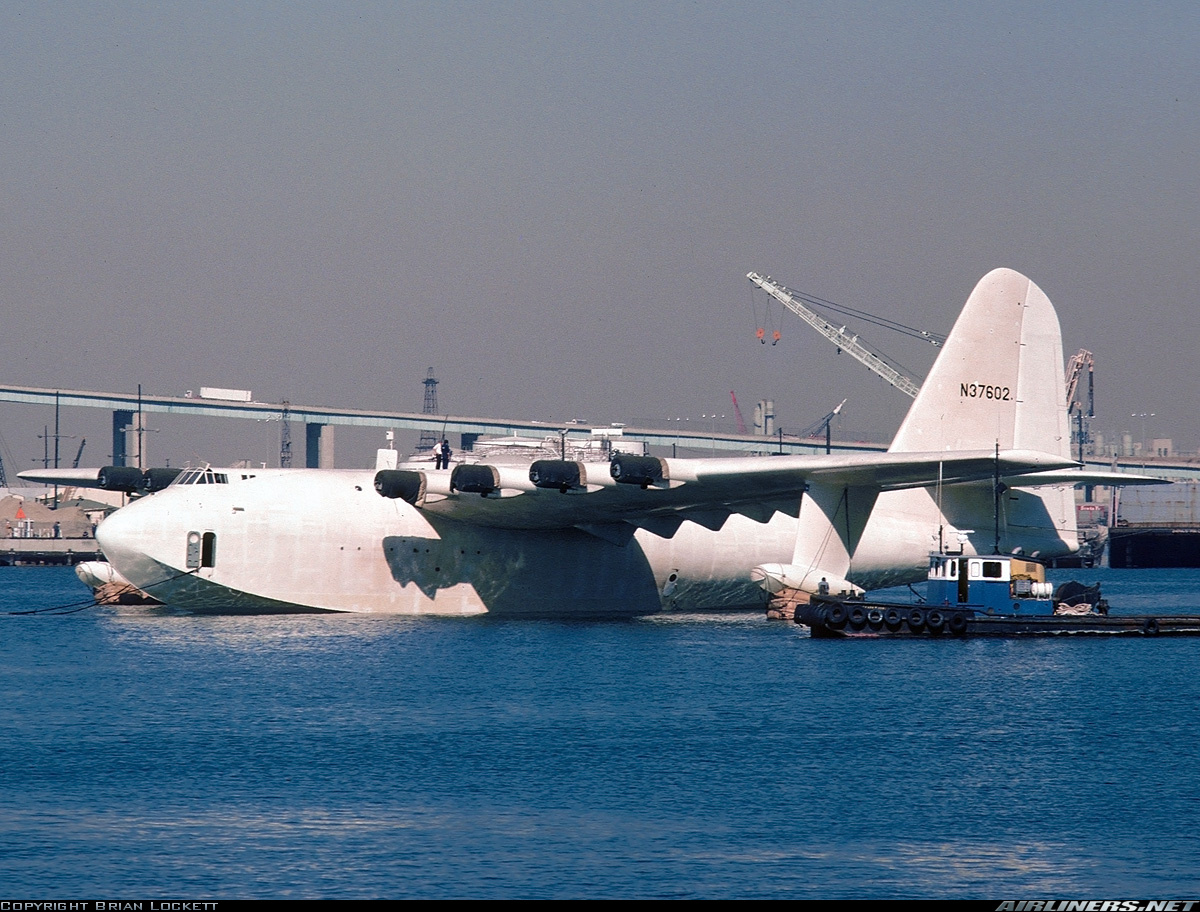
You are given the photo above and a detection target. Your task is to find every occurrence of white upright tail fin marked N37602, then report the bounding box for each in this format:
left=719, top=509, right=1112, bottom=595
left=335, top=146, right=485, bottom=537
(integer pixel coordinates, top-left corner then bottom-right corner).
left=889, top=269, right=1070, bottom=457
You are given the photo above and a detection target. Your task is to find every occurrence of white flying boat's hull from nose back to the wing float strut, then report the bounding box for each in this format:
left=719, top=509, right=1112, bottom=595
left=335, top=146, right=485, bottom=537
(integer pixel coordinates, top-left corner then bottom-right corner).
left=97, top=470, right=796, bottom=617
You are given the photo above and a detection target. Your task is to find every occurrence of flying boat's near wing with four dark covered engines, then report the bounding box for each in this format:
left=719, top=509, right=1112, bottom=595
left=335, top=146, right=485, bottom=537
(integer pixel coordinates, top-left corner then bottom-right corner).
left=376, top=450, right=1076, bottom=538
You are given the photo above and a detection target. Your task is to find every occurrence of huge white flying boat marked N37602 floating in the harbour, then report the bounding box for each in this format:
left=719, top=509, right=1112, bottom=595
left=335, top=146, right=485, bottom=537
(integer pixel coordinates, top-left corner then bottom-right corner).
left=23, top=269, right=1151, bottom=617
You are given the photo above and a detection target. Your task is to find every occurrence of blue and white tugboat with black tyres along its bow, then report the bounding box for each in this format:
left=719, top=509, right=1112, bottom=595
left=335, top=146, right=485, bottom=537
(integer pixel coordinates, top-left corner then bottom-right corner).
left=794, top=552, right=1200, bottom=637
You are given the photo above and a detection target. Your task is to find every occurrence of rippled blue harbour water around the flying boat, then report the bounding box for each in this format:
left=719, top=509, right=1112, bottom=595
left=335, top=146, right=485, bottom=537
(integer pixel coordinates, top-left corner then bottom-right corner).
left=0, top=568, right=1200, bottom=899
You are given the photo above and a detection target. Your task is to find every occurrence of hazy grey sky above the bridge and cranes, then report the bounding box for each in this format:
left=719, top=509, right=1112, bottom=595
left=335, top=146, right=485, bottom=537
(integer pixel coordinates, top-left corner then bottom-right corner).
left=0, top=0, right=1200, bottom=472
